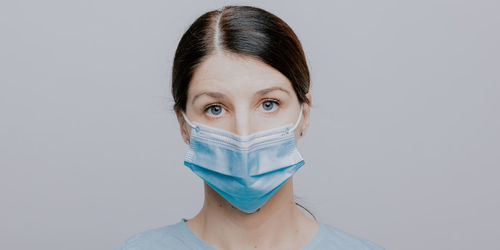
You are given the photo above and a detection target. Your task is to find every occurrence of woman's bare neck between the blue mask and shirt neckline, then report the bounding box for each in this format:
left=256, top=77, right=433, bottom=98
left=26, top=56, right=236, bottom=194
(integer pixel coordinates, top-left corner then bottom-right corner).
left=187, top=178, right=319, bottom=249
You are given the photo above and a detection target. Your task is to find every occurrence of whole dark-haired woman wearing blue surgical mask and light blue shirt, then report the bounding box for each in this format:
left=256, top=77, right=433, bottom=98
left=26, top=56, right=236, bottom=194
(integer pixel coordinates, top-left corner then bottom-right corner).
left=117, top=6, right=382, bottom=249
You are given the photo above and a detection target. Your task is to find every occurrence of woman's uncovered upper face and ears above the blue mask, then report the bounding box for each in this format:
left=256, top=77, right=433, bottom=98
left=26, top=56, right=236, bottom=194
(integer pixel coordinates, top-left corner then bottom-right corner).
left=176, top=53, right=311, bottom=143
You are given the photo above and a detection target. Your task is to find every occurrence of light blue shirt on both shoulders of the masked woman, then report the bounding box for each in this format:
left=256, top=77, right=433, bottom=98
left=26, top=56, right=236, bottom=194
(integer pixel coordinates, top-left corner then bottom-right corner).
left=116, top=218, right=384, bottom=250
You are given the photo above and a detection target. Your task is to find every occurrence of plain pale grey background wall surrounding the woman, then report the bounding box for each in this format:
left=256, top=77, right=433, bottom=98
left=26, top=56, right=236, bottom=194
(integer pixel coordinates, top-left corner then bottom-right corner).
left=0, top=0, right=500, bottom=250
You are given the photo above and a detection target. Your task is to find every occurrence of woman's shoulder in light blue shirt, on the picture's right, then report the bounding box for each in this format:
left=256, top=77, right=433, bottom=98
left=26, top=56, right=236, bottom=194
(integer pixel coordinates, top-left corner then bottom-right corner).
left=305, top=223, right=385, bottom=250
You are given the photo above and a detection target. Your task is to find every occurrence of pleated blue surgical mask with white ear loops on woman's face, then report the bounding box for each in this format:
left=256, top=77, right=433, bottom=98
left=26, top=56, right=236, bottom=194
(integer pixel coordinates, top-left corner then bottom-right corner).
left=182, top=105, right=304, bottom=213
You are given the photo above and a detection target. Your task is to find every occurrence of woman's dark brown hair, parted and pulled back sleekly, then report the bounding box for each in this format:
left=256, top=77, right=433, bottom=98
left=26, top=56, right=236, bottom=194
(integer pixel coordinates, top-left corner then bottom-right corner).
left=172, top=5, right=310, bottom=111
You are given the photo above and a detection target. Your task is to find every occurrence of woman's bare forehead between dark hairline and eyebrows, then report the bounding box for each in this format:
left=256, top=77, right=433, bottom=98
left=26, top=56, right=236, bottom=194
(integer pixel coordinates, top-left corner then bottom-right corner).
left=188, top=53, right=293, bottom=96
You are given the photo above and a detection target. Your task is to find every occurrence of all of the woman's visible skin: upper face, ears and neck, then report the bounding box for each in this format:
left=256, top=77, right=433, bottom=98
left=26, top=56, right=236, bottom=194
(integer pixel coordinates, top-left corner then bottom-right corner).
left=176, top=52, right=319, bottom=249
